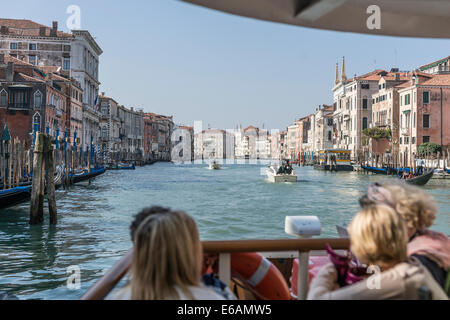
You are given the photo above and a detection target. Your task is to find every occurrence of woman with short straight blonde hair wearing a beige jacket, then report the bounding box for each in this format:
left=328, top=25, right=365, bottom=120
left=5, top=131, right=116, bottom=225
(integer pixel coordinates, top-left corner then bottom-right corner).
left=308, top=205, right=447, bottom=300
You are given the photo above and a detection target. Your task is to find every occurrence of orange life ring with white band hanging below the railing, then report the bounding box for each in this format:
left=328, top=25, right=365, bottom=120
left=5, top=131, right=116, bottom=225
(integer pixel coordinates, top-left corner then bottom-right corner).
left=231, top=253, right=291, bottom=300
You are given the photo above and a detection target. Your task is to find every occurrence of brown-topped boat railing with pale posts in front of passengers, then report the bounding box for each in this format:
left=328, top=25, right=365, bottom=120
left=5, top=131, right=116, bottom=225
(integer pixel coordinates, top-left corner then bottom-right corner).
left=81, top=238, right=350, bottom=300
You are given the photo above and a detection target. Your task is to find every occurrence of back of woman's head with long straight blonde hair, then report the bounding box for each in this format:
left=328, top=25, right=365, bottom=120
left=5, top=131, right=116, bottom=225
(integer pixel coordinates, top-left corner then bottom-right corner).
left=130, top=207, right=202, bottom=300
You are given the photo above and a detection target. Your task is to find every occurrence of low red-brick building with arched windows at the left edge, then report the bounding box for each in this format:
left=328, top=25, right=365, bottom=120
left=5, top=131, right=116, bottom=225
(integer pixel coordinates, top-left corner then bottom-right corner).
left=0, top=54, right=75, bottom=147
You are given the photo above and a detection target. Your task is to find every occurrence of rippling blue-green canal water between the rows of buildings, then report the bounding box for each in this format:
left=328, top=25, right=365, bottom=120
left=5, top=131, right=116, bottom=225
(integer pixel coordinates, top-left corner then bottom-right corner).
left=0, top=163, right=450, bottom=299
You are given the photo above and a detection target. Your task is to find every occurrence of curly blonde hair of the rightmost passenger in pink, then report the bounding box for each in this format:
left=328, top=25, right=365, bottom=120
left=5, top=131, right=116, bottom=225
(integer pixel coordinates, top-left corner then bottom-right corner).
left=383, top=183, right=437, bottom=230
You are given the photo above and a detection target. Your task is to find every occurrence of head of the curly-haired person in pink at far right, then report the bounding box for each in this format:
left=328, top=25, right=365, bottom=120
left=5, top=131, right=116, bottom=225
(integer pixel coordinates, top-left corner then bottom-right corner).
left=360, top=183, right=437, bottom=237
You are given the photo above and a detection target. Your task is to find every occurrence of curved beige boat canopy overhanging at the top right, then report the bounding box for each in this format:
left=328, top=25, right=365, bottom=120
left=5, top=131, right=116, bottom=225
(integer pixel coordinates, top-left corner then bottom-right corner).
left=181, top=0, right=450, bottom=38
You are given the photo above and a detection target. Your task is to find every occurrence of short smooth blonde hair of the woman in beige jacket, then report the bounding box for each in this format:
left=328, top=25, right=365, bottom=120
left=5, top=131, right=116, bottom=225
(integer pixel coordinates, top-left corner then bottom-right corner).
left=348, top=204, right=408, bottom=268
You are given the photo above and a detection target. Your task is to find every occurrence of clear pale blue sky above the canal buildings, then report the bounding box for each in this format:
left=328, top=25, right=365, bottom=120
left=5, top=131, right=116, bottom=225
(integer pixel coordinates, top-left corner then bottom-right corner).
left=0, top=0, right=450, bottom=129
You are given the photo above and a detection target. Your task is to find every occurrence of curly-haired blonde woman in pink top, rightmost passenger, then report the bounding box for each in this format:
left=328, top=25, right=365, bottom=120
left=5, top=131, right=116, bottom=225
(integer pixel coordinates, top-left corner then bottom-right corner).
left=360, top=183, right=450, bottom=294
